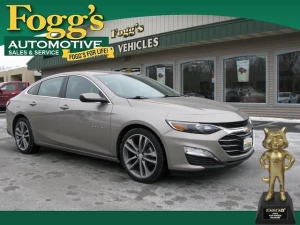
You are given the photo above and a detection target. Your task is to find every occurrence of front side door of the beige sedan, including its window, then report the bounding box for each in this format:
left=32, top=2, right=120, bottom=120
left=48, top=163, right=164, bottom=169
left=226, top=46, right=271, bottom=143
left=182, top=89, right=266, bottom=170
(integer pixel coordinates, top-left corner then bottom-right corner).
left=58, top=75, right=113, bottom=156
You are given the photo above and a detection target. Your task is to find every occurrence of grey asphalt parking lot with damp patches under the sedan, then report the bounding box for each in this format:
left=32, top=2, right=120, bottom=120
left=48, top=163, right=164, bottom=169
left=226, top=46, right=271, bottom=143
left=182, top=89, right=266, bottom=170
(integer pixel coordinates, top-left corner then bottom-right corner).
left=0, top=113, right=300, bottom=211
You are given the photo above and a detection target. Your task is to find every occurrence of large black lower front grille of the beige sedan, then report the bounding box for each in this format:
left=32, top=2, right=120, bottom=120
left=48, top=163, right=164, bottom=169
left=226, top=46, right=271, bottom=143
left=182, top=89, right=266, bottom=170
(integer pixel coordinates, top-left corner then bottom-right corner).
left=219, top=129, right=253, bottom=156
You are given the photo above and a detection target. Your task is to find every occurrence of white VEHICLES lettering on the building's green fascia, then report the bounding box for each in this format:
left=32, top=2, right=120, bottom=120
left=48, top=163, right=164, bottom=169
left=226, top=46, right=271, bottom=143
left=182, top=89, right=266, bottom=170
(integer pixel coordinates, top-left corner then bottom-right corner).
left=118, top=37, right=159, bottom=53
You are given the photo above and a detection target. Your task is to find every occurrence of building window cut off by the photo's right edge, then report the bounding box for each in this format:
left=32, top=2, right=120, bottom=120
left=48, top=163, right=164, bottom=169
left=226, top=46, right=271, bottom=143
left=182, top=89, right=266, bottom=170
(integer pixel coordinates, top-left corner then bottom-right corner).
left=277, top=51, right=300, bottom=104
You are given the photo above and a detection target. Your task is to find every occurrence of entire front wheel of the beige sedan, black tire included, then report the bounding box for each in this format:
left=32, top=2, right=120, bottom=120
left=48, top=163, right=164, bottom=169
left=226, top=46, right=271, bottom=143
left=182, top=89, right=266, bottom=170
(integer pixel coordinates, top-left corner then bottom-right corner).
left=120, top=128, right=166, bottom=184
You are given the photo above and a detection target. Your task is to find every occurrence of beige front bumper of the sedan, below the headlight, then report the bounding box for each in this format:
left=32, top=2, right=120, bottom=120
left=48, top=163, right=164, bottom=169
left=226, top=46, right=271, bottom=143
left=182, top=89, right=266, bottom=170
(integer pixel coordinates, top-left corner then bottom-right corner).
left=163, top=126, right=255, bottom=172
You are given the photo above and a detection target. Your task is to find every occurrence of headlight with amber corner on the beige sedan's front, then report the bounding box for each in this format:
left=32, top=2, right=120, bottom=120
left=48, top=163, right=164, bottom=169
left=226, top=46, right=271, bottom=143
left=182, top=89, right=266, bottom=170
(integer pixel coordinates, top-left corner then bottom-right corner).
left=167, top=120, right=221, bottom=134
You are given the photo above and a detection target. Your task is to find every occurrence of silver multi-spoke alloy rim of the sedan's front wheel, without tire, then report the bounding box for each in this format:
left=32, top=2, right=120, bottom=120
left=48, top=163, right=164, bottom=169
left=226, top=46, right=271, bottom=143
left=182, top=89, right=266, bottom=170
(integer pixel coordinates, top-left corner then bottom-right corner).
left=123, top=134, right=157, bottom=178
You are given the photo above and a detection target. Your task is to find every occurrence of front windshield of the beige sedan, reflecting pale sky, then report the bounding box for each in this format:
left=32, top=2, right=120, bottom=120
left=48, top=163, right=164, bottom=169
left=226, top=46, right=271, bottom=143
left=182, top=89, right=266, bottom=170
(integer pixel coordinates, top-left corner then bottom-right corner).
left=95, top=74, right=181, bottom=99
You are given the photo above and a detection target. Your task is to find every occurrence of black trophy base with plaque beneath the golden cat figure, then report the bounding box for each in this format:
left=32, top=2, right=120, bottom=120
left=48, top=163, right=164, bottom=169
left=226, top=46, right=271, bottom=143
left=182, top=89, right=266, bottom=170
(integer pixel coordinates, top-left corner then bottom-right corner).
left=255, top=192, right=296, bottom=225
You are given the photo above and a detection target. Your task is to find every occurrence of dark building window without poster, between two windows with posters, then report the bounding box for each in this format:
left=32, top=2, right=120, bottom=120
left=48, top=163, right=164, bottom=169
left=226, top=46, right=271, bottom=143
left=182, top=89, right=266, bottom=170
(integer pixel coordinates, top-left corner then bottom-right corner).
left=181, top=60, right=215, bottom=100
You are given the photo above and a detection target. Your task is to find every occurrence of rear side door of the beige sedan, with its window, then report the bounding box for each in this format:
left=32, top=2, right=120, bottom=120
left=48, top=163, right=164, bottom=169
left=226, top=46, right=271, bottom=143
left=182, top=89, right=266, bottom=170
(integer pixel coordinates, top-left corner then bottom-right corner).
left=23, top=76, right=65, bottom=145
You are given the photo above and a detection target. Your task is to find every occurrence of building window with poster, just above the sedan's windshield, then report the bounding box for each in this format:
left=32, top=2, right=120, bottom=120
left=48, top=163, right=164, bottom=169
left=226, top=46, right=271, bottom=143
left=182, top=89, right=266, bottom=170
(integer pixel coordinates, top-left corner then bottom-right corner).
left=146, top=64, right=174, bottom=88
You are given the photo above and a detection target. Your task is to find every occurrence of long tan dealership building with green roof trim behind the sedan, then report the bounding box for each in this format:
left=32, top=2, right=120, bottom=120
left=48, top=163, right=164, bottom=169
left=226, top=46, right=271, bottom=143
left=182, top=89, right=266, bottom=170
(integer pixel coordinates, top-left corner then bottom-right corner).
left=27, top=15, right=300, bottom=119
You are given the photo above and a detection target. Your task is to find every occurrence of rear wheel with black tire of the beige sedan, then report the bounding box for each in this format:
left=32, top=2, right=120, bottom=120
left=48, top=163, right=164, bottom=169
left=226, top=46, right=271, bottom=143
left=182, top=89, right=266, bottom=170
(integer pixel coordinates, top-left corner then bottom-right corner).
left=14, top=118, right=40, bottom=154
